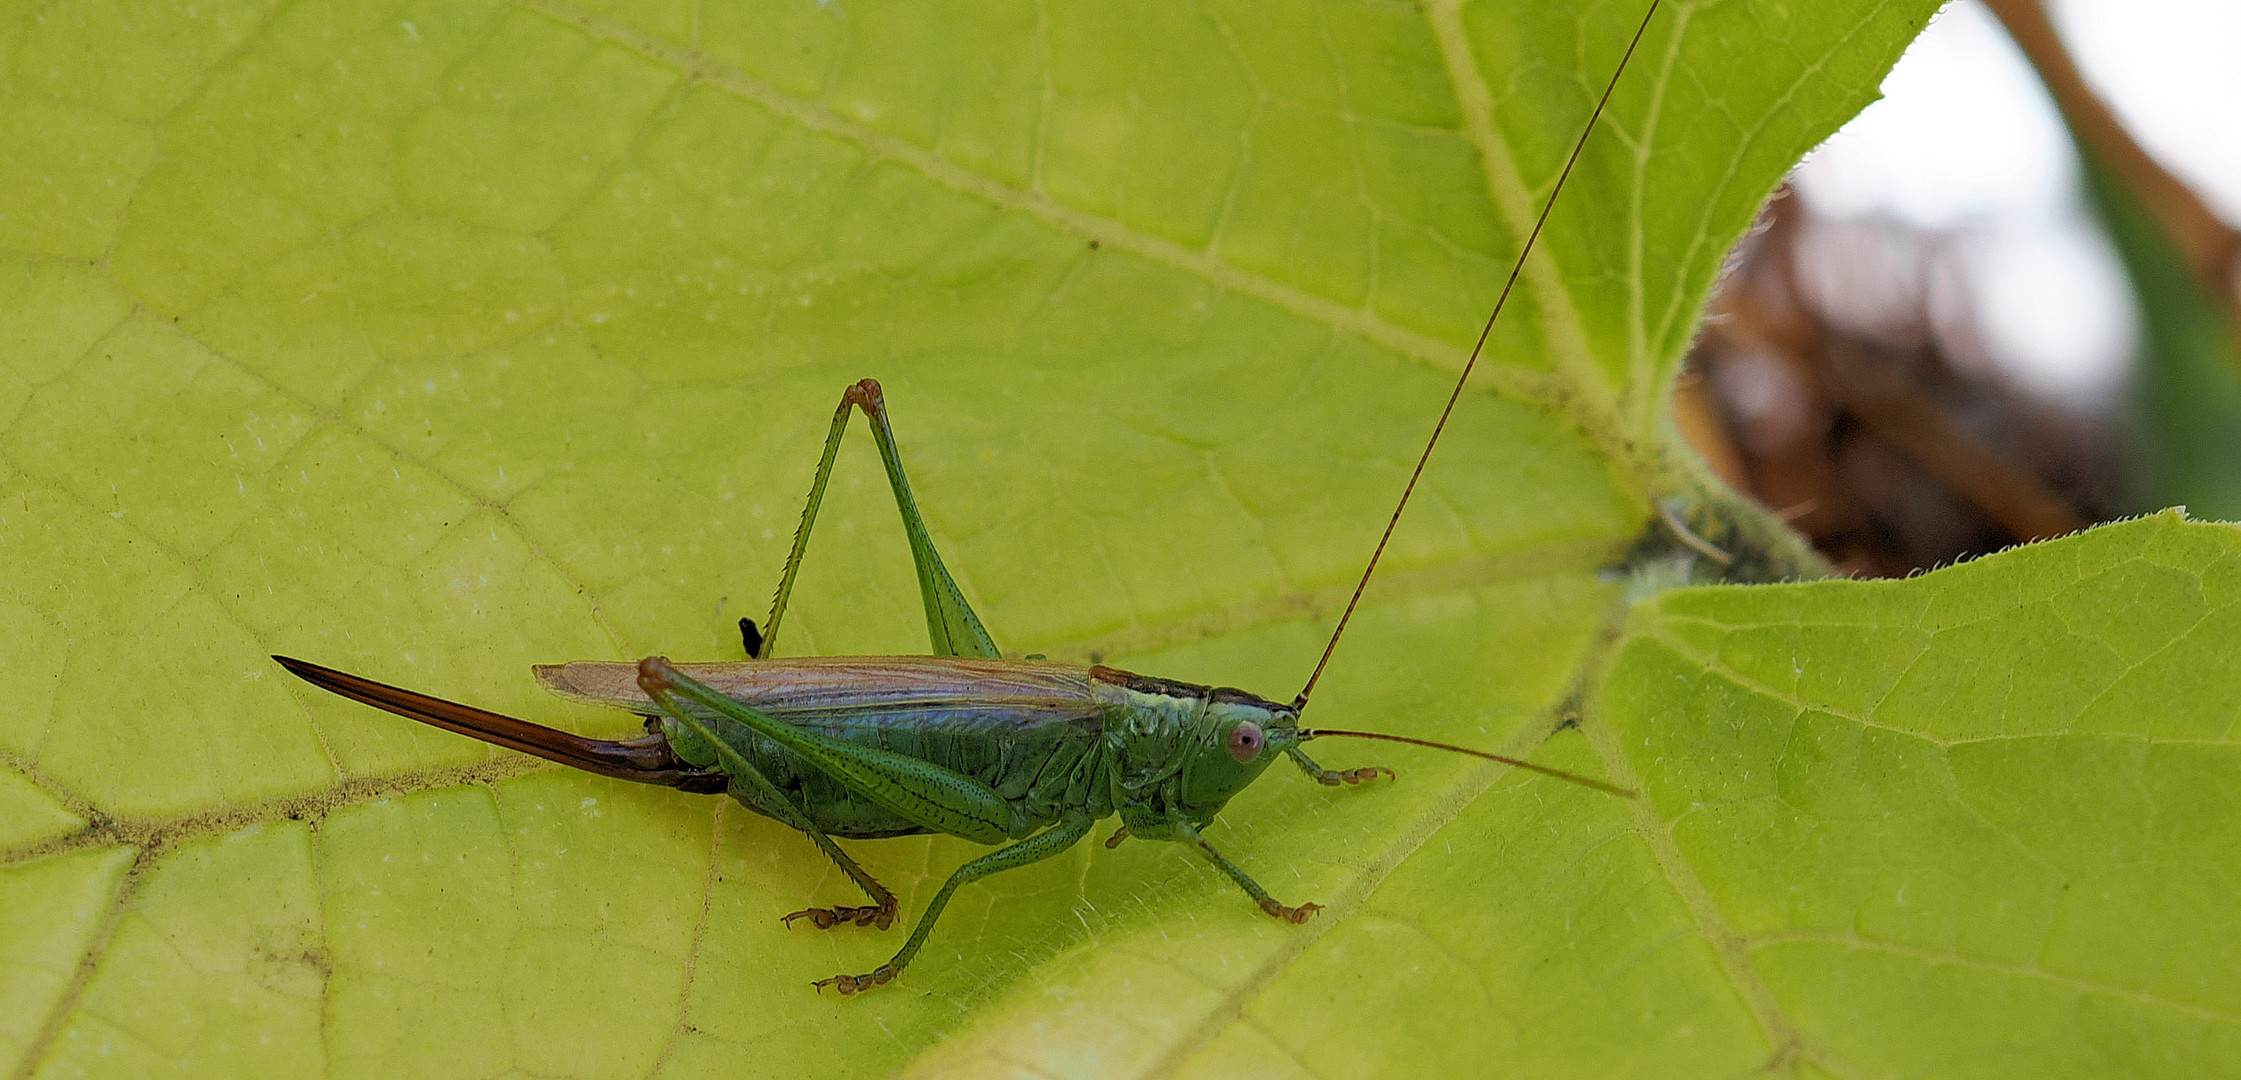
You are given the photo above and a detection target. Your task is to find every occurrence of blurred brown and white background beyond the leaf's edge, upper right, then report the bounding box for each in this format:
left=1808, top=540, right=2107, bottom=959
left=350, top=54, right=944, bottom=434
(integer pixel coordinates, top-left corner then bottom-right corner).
left=1676, top=0, right=2241, bottom=576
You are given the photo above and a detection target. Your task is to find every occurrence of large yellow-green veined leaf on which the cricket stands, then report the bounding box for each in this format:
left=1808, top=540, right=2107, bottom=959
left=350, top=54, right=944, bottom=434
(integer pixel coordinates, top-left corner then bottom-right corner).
left=13, top=0, right=2241, bottom=1076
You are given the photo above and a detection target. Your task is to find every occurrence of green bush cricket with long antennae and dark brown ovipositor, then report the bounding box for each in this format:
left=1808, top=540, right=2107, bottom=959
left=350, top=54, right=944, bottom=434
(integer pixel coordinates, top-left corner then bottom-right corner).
left=273, top=0, right=1658, bottom=995
